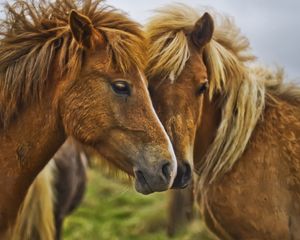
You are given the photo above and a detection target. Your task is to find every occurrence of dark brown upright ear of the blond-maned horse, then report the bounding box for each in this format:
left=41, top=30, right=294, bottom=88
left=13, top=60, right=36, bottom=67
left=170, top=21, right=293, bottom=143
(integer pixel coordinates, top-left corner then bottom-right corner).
left=191, top=13, right=214, bottom=48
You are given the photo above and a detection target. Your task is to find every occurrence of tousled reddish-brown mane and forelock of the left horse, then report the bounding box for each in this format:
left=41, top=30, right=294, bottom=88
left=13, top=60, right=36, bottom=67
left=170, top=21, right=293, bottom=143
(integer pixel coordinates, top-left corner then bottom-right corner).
left=0, top=0, right=145, bottom=127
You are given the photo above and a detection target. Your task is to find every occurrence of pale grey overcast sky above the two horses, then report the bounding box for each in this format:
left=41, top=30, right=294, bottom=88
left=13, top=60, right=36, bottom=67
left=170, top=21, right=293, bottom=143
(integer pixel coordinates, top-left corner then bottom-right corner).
left=106, top=0, right=300, bottom=79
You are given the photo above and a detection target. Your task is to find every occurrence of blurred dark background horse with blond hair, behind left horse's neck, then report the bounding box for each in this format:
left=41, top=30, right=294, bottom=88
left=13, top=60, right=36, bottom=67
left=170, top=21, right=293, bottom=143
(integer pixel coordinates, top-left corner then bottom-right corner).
left=12, top=138, right=89, bottom=240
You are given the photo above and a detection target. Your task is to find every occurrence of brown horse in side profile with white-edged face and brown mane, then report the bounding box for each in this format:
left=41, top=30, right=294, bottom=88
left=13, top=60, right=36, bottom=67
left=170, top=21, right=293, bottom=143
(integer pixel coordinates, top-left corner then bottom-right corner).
left=0, top=0, right=177, bottom=239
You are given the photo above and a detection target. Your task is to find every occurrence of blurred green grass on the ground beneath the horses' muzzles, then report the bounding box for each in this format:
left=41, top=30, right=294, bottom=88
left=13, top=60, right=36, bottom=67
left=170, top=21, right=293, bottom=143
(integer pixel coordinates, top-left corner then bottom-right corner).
left=64, top=170, right=212, bottom=240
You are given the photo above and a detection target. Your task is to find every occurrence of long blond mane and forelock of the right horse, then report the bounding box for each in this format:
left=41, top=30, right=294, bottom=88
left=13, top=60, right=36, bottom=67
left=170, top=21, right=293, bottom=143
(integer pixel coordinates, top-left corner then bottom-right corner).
left=146, top=4, right=300, bottom=186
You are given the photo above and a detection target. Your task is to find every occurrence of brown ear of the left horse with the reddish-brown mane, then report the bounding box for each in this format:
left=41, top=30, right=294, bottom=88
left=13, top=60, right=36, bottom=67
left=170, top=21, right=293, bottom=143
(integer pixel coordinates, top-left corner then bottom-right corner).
left=69, top=10, right=100, bottom=49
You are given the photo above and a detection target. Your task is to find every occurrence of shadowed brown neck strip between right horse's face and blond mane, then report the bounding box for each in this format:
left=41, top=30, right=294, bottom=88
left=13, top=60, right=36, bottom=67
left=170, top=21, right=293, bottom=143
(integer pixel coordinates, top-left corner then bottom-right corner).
left=194, top=94, right=221, bottom=166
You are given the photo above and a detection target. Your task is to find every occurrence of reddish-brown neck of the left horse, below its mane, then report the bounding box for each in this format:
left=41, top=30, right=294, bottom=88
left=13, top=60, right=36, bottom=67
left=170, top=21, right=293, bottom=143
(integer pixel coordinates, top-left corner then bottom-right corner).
left=0, top=88, right=65, bottom=232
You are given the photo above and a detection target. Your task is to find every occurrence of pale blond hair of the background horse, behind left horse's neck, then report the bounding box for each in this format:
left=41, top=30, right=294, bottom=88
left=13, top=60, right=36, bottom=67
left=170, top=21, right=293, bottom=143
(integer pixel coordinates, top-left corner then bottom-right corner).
left=11, top=160, right=56, bottom=240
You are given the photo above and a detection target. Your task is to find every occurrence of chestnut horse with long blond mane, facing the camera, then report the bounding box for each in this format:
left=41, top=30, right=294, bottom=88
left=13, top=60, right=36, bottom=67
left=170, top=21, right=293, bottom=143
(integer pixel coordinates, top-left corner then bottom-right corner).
left=146, top=5, right=300, bottom=240
